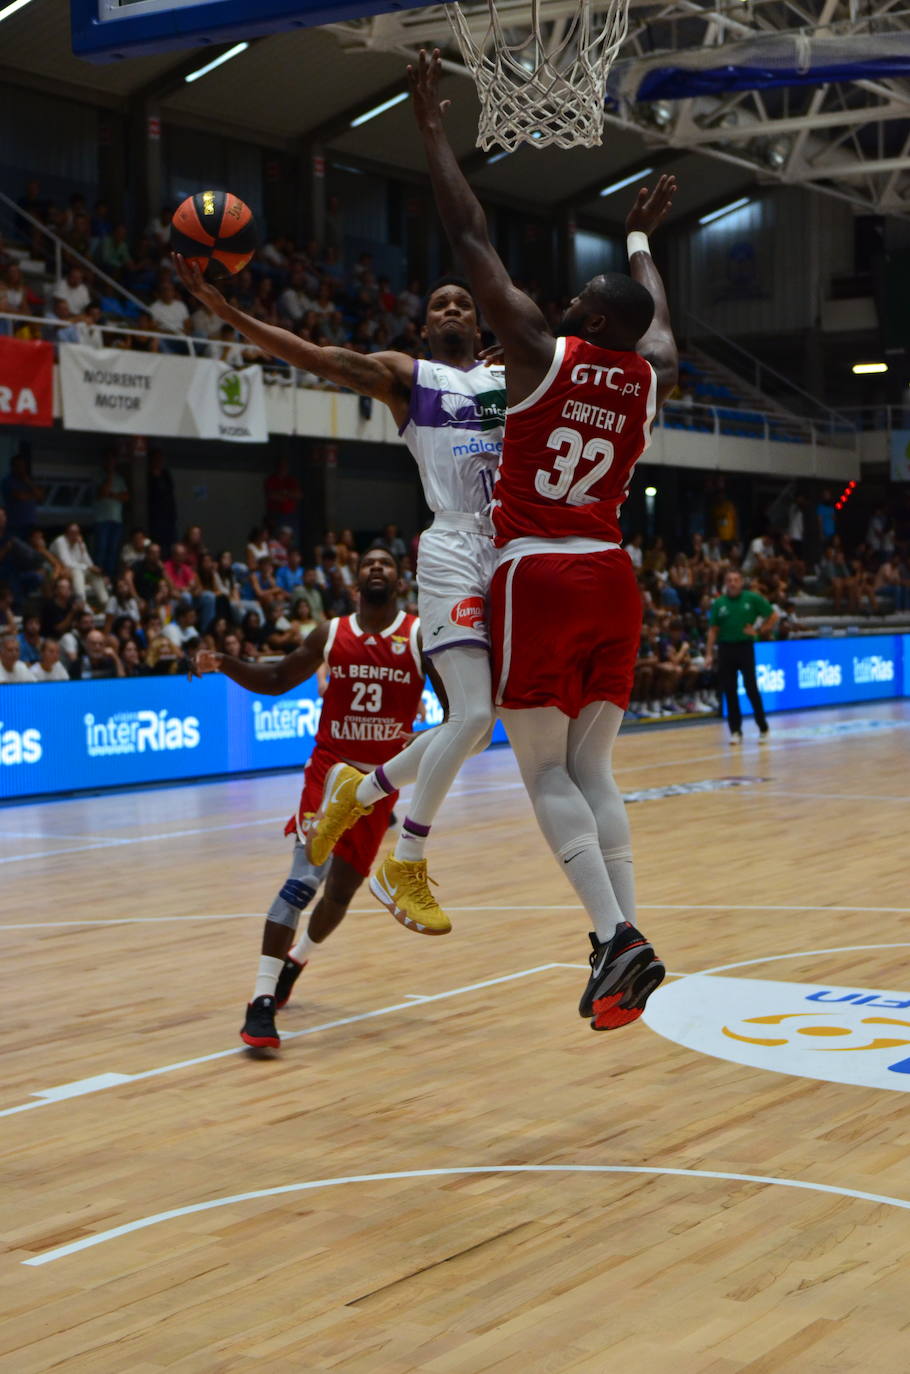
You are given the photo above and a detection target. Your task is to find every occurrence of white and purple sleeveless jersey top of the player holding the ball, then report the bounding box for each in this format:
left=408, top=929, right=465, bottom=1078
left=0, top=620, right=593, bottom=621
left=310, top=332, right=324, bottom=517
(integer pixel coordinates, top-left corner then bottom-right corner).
left=401, top=359, right=506, bottom=515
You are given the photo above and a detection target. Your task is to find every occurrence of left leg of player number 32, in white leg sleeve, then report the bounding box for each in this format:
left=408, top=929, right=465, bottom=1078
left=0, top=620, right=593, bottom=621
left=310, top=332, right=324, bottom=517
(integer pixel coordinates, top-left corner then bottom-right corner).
left=500, top=706, right=623, bottom=940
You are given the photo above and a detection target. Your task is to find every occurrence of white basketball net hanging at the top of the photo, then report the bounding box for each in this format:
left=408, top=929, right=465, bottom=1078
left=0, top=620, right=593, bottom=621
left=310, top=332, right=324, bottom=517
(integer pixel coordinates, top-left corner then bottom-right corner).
left=445, top=0, right=628, bottom=151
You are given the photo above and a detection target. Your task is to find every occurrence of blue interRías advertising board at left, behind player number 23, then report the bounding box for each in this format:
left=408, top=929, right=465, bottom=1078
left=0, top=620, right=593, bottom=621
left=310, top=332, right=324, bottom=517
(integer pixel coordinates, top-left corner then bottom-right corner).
left=0, top=673, right=506, bottom=813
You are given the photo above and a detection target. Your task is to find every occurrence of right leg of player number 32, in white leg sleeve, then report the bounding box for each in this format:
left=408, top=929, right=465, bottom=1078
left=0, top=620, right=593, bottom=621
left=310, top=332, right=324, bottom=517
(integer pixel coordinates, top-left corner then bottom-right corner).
left=569, top=701, right=635, bottom=926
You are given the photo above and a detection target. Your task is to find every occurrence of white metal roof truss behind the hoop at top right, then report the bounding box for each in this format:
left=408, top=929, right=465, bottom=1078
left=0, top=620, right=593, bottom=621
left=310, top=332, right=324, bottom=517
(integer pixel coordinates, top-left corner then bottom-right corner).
left=333, top=0, right=910, bottom=217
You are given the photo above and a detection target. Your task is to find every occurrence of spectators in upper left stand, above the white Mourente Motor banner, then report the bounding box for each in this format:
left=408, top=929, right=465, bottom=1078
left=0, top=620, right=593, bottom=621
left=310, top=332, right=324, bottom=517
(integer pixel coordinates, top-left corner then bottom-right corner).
left=0, top=181, right=470, bottom=386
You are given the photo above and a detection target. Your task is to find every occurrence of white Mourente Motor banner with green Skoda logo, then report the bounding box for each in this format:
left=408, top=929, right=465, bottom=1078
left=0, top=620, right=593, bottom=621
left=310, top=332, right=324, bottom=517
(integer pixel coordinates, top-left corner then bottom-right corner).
left=60, top=344, right=268, bottom=444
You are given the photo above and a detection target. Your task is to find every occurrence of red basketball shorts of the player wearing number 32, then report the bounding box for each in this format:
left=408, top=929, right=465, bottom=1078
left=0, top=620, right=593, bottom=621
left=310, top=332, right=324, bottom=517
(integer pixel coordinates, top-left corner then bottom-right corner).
left=489, top=548, right=642, bottom=717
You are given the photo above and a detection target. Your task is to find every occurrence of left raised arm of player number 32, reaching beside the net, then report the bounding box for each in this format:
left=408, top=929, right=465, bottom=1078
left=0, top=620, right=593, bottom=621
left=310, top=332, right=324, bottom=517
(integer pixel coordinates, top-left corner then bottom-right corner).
left=408, top=48, right=554, bottom=405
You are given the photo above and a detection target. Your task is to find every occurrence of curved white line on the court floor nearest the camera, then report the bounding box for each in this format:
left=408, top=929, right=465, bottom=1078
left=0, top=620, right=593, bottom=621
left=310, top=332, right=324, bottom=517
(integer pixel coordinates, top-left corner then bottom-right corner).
left=19, top=1164, right=910, bottom=1268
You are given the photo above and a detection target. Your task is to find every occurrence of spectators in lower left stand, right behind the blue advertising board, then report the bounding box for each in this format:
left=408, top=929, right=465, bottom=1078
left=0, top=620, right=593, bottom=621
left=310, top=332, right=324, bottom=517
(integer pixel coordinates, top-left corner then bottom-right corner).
left=0, top=453, right=417, bottom=683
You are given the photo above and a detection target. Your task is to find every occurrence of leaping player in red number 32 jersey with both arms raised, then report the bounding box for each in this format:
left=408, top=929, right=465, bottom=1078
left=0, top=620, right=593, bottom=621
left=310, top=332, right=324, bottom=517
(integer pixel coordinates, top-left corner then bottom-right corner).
left=408, top=51, right=678, bottom=1031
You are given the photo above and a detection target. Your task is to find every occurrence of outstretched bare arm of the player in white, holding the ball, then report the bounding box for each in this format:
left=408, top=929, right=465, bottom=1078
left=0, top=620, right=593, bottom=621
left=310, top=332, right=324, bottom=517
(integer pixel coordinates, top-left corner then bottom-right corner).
left=173, top=253, right=414, bottom=425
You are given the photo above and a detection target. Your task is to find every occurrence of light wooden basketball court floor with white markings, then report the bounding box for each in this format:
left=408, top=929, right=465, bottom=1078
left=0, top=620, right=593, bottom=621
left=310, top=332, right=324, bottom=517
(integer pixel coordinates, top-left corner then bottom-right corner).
left=0, top=703, right=910, bottom=1374
